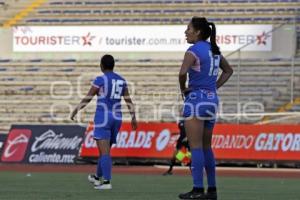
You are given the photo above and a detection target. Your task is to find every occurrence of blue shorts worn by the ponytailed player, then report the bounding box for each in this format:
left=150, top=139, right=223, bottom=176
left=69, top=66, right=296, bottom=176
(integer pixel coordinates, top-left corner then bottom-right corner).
left=183, top=89, right=219, bottom=128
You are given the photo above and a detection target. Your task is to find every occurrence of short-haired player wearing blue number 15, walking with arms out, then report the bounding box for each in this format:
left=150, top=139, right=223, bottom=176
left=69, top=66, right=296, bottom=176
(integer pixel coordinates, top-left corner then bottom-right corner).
left=71, top=55, right=137, bottom=190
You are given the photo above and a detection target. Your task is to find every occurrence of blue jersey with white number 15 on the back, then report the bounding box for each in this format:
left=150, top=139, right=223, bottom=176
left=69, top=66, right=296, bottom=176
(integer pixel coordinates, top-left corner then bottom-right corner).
left=92, top=71, right=127, bottom=117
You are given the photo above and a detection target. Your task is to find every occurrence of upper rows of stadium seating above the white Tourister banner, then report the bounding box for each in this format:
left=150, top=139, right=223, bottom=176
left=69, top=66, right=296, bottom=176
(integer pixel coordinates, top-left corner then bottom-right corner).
left=3, top=0, right=300, bottom=25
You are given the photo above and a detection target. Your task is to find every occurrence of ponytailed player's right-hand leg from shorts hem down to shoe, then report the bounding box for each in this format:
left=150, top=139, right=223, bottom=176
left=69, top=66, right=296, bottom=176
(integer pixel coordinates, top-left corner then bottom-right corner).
left=203, top=124, right=217, bottom=200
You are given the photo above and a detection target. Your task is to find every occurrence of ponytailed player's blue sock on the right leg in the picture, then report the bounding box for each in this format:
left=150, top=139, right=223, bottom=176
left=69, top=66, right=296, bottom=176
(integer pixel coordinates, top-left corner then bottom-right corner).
left=203, top=148, right=216, bottom=187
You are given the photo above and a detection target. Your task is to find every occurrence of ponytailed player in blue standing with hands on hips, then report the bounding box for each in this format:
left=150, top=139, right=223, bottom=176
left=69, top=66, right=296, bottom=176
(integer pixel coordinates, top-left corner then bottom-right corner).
left=179, top=17, right=233, bottom=200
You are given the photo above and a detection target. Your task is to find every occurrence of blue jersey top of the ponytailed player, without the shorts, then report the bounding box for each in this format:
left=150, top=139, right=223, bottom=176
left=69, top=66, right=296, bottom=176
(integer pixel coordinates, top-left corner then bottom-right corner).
left=187, top=41, right=221, bottom=91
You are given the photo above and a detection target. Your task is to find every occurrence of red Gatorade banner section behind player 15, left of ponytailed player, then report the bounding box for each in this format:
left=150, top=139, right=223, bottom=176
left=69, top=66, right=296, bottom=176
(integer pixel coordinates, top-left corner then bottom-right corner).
left=80, top=123, right=179, bottom=158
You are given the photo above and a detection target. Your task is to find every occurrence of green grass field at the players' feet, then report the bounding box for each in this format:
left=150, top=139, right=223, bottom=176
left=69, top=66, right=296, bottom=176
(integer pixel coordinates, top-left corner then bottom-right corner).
left=0, top=172, right=300, bottom=200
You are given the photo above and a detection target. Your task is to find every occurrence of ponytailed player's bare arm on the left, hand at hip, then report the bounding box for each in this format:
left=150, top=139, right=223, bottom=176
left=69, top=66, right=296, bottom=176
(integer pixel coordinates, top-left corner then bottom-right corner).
left=179, top=52, right=196, bottom=95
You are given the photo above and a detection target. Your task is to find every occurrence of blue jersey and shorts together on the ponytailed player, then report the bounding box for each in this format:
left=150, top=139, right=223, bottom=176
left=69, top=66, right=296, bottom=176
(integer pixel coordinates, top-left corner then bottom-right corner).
left=183, top=41, right=221, bottom=128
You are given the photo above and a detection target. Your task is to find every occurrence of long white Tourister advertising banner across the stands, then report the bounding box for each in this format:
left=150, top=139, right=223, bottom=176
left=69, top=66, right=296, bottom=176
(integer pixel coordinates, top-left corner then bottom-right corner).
left=13, top=25, right=272, bottom=52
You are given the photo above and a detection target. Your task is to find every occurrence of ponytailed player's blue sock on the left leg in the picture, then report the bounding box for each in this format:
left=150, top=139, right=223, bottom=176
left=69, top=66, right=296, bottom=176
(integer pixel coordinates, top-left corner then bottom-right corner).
left=191, top=148, right=204, bottom=188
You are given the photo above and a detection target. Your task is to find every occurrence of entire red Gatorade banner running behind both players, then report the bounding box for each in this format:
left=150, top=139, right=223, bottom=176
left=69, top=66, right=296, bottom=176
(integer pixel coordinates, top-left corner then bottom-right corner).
left=80, top=123, right=300, bottom=161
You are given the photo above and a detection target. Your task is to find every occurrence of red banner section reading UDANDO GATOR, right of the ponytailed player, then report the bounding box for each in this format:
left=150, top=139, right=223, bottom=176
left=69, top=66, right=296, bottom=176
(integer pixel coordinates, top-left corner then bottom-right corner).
left=212, top=124, right=300, bottom=161
